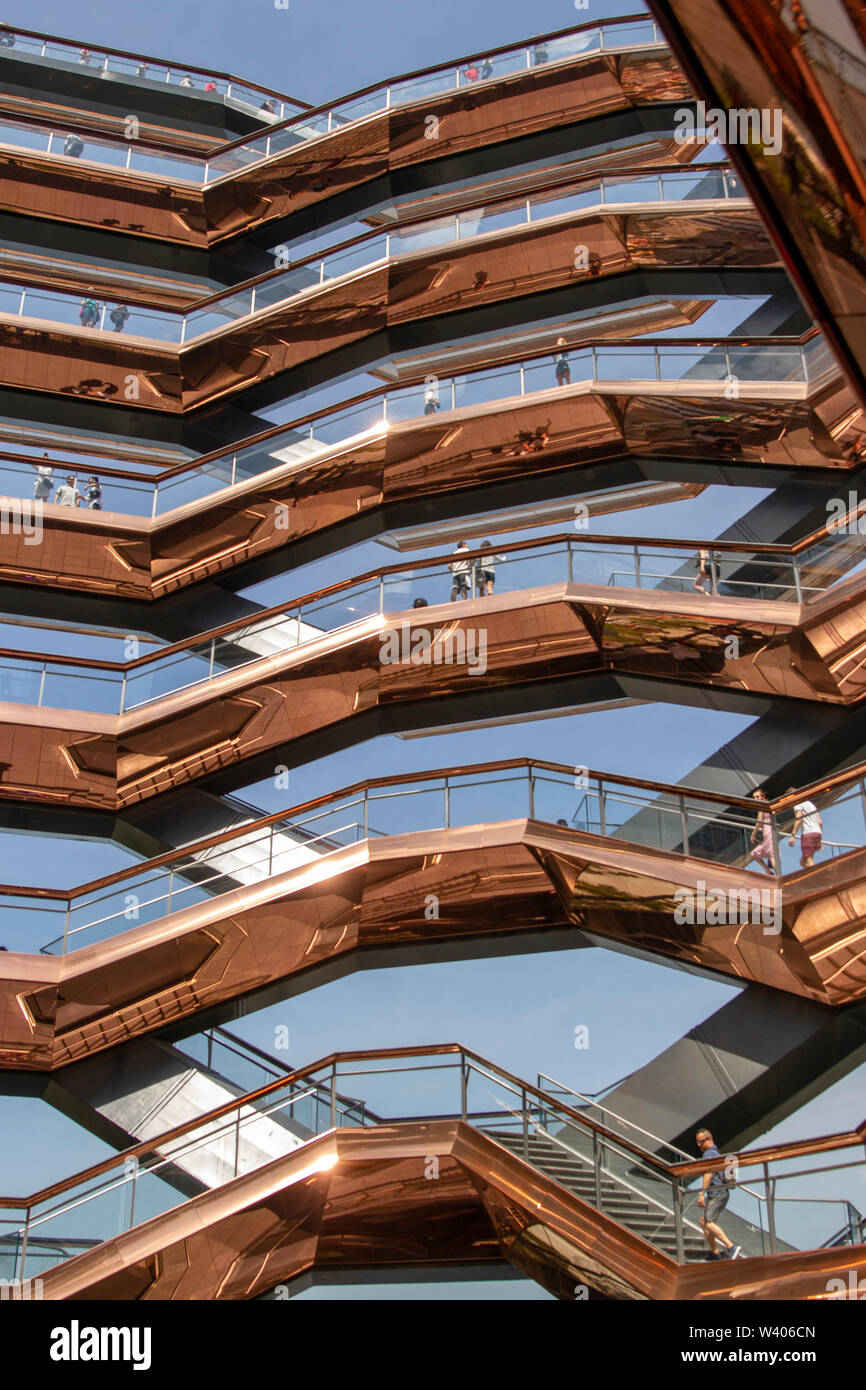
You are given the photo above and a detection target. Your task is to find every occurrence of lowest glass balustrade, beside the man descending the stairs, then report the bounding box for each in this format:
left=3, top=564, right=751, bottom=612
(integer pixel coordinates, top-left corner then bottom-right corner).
left=0, top=1045, right=866, bottom=1280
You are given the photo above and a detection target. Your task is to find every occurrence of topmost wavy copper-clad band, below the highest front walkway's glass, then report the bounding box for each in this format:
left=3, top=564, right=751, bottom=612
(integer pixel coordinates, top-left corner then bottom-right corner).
left=0, top=46, right=691, bottom=246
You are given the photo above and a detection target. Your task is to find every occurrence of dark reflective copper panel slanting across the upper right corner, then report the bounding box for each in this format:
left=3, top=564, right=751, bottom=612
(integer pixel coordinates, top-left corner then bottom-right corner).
left=649, top=0, right=866, bottom=400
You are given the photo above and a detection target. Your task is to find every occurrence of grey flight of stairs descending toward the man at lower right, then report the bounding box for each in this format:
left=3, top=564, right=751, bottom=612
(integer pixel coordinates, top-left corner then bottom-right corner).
left=484, top=1129, right=709, bottom=1261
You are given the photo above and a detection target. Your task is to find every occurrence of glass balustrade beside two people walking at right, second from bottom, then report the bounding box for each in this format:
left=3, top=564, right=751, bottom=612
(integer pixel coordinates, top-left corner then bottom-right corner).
left=0, top=763, right=866, bottom=955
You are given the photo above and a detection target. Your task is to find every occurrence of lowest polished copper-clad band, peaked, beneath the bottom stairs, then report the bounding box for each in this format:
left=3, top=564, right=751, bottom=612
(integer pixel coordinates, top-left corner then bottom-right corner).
left=27, top=1120, right=866, bottom=1301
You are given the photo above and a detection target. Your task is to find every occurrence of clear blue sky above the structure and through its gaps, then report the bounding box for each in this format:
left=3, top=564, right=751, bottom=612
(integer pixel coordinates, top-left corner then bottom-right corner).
left=0, top=0, right=863, bottom=1298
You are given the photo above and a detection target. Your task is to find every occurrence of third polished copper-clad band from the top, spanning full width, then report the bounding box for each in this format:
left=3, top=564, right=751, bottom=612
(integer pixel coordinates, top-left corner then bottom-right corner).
left=0, top=366, right=863, bottom=602
